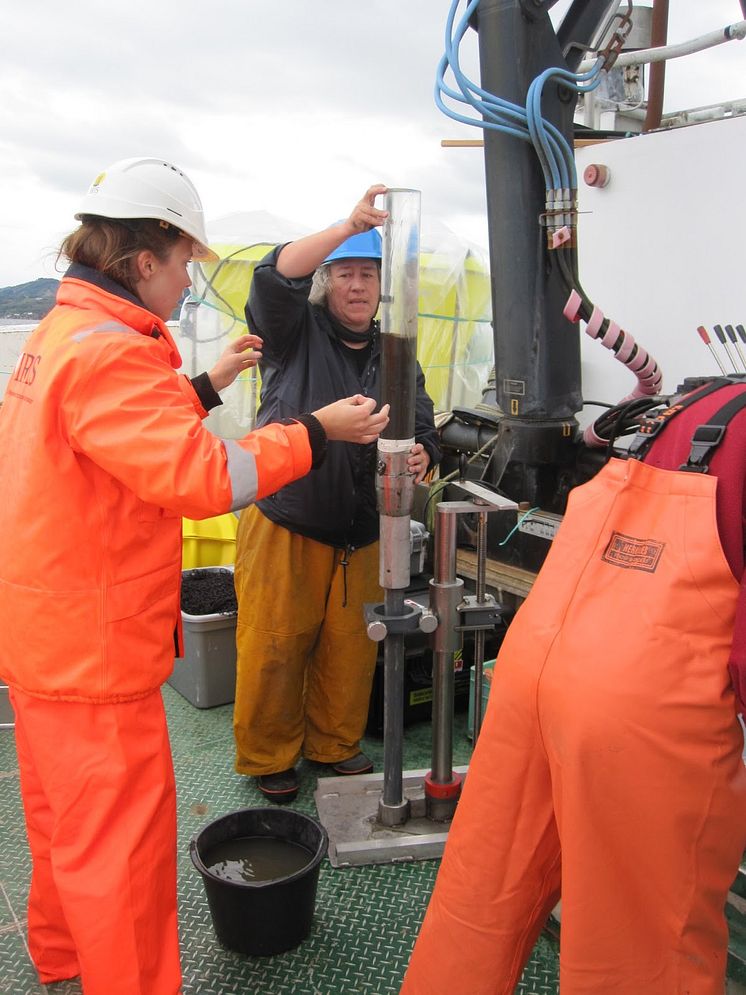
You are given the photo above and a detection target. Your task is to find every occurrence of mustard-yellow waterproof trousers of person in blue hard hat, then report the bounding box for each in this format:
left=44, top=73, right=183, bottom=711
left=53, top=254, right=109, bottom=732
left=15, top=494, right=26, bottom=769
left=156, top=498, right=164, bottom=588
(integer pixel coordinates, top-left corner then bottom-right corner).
left=233, top=506, right=383, bottom=775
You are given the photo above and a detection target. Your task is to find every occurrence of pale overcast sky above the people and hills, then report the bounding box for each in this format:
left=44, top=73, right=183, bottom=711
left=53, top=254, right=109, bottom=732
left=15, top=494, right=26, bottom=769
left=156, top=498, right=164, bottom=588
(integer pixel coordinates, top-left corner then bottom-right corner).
left=0, top=0, right=746, bottom=286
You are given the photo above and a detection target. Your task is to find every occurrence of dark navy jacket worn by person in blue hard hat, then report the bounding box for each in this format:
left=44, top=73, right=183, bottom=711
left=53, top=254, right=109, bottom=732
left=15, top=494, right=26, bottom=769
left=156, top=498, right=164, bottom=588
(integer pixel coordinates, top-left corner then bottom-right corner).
left=246, top=246, right=440, bottom=549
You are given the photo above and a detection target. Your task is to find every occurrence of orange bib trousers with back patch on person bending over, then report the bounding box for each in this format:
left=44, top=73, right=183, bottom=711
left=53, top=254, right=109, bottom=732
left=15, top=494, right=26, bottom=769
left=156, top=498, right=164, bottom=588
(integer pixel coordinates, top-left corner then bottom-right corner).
left=401, top=460, right=746, bottom=995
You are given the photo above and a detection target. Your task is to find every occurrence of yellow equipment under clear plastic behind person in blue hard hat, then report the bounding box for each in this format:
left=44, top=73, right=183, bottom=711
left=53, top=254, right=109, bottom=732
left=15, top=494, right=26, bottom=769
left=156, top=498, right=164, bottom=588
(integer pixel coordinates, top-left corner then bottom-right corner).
left=176, top=212, right=494, bottom=568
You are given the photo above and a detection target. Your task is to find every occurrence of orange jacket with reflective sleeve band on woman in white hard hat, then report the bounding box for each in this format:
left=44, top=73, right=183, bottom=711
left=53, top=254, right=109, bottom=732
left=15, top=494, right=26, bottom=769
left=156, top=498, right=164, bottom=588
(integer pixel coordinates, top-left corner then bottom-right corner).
left=0, top=266, right=312, bottom=702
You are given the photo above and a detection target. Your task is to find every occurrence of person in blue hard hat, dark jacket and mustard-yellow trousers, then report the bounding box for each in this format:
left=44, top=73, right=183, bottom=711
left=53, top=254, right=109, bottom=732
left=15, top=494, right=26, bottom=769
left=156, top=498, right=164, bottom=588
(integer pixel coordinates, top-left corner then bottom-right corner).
left=233, top=185, right=440, bottom=802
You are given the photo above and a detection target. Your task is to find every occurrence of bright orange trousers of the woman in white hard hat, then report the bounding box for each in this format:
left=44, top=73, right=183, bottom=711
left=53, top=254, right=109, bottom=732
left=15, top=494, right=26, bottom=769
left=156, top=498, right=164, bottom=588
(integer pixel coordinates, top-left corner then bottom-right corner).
left=10, top=690, right=181, bottom=995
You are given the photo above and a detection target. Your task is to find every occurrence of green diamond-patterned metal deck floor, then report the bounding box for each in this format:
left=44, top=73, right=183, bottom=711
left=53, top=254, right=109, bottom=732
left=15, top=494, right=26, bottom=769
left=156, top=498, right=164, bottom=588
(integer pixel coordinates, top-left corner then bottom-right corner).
left=0, top=685, right=743, bottom=995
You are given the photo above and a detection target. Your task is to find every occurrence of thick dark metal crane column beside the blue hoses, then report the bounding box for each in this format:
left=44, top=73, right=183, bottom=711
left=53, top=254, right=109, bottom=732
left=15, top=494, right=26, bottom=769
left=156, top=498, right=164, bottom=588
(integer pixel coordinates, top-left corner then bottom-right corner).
left=444, top=0, right=626, bottom=510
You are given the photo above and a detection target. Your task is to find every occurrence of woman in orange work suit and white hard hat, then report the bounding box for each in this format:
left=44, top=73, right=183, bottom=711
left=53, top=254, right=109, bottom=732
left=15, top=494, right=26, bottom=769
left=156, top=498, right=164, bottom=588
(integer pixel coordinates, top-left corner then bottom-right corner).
left=0, top=159, right=387, bottom=995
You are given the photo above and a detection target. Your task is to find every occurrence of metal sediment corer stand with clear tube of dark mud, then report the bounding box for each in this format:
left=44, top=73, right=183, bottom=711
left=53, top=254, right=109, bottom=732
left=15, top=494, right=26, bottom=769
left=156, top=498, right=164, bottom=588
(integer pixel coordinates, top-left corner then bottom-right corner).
left=314, top=189, right=517, bottom=867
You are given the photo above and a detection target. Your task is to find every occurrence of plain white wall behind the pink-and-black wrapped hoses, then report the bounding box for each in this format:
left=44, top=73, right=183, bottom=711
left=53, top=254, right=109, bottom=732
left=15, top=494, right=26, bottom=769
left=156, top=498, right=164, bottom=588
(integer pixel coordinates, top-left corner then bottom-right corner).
left=576, top=116, right=746, bottom=424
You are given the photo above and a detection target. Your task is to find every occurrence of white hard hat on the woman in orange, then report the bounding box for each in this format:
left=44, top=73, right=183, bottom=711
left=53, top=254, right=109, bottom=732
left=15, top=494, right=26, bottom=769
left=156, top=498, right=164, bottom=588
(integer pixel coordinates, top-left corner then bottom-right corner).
left=75, top=159, right=218, bottom=262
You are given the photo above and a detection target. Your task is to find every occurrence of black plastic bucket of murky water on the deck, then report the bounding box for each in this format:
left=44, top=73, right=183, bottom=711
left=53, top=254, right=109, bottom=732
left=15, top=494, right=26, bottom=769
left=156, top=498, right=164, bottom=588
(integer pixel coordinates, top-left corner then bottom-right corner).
left=189, top=808, right=329, bottom=956
